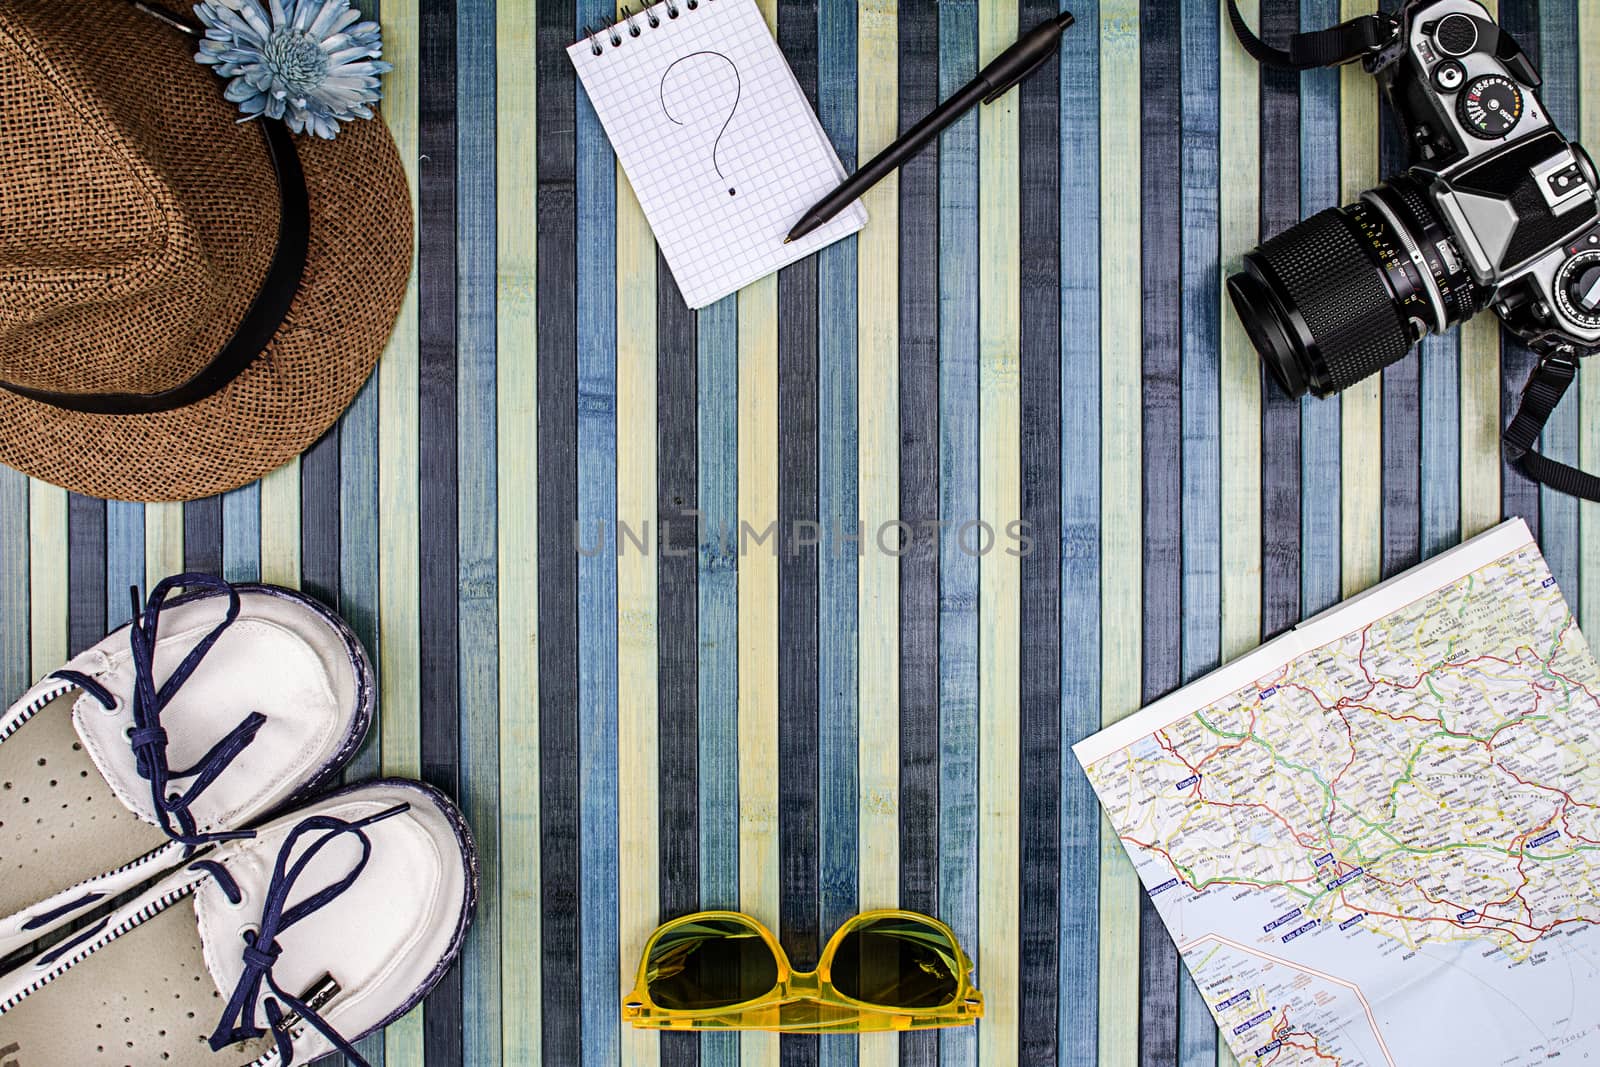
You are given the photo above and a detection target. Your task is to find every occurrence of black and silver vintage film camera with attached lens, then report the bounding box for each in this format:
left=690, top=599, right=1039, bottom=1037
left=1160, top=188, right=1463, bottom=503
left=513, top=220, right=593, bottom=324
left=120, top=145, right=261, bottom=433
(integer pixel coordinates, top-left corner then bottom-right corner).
left=1227, top=0, right=1600, bottom=397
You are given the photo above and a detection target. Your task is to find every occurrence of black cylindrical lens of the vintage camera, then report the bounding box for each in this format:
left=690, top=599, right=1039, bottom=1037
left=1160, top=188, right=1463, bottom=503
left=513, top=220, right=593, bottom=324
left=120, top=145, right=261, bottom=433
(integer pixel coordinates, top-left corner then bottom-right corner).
left=1227, top=176, right=1482, bottom=397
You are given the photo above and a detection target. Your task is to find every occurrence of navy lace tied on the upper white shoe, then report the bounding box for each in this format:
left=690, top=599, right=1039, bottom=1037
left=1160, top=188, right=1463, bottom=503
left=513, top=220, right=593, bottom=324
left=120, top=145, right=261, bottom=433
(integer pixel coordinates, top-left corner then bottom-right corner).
left=54, top=574, right=267, bottom=851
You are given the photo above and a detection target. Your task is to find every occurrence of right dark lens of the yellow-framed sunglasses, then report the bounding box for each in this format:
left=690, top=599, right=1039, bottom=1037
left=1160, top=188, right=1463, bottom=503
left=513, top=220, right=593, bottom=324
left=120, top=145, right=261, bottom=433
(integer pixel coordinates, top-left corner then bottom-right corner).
left=832, top=918, right=962, bottom=1008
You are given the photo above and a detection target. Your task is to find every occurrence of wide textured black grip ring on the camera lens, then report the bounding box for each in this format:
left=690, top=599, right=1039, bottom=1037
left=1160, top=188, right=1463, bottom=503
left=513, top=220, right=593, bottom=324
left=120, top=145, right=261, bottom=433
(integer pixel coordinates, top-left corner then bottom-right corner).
left=1253, top=208, right=1413, bottom=395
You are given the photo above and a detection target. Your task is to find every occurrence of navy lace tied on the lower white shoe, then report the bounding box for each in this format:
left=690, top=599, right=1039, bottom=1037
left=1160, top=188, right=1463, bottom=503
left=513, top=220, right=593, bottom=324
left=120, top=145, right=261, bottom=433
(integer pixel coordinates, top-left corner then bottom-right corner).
left=203, top=803, right=411, bottom=1067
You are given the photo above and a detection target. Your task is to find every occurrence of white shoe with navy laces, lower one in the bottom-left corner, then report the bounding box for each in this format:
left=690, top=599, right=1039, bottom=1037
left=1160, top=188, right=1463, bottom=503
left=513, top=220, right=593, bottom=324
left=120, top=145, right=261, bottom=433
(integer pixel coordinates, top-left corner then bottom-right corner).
left=0, top=779, right=477, bottom=1067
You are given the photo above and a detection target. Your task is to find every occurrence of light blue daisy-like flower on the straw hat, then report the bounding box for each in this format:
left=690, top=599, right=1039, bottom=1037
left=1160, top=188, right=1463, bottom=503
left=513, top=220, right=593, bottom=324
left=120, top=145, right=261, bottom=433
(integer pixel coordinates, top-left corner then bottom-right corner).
left=195, top=0, right=394, bottom=138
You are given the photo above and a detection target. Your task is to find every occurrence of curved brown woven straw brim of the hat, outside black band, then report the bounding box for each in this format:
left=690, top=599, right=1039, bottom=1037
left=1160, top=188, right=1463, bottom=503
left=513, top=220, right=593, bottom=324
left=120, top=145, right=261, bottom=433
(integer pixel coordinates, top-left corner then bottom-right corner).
left=0, top=82, right=411, bottom=501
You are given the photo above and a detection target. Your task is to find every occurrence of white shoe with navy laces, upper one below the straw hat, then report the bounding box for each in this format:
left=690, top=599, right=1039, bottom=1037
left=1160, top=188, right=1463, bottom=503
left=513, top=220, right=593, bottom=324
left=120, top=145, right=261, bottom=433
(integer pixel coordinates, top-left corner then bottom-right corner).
left=0, top=574, right=374, bottom=959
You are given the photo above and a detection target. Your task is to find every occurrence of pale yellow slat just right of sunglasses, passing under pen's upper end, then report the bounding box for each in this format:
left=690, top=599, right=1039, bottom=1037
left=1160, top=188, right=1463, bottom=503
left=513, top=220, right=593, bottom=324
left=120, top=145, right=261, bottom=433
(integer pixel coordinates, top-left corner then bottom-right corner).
left=966, top=0, right=1017, bottom=1065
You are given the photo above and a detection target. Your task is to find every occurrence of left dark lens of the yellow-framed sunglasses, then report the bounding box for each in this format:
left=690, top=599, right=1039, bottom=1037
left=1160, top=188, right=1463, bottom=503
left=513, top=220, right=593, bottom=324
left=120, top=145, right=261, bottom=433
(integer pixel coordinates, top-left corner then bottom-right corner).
left=646, top=918, right=778, bottom=1011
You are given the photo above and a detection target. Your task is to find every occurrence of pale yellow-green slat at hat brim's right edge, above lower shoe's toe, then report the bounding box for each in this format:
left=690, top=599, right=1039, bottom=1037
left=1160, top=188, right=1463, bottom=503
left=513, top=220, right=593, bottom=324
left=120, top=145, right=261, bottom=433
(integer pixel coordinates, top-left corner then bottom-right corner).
left=374, top=0, right=424, bottom=1067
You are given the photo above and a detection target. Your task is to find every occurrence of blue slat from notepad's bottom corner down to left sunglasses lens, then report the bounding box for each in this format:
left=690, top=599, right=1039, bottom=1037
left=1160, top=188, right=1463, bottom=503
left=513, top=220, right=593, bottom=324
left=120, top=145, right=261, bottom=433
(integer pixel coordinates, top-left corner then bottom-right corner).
left=698, top=296, right=739, bottom=1067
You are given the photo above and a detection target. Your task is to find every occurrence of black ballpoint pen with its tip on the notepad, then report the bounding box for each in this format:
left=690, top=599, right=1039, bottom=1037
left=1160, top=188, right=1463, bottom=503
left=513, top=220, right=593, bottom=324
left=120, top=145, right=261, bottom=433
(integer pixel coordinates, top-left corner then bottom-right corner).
left=784, top=11, right=1072, bottom=245
